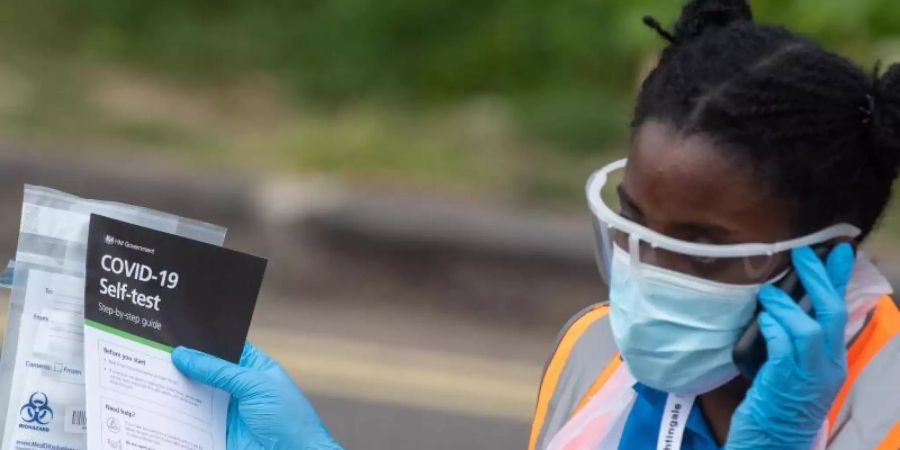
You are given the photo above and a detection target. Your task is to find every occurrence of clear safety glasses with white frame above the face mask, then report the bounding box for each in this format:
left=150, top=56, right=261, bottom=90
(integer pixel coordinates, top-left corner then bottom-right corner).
left=586, top=159, right=860, bottom=284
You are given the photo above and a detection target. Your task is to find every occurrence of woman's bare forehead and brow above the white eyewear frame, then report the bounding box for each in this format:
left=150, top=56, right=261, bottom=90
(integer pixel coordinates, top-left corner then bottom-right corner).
left=619, top=121, right=795, bottom=278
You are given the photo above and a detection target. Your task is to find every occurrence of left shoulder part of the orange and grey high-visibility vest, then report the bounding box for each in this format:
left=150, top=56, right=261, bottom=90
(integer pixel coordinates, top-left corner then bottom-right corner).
left=528, top=304, right=616, bottom=450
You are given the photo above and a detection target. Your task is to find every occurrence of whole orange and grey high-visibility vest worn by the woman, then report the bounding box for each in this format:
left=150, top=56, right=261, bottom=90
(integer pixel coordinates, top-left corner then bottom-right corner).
left=528, top=296, right=900, bottom=450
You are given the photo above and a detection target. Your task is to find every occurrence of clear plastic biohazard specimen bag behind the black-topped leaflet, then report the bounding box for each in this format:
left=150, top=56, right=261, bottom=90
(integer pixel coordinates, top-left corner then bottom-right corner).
left=0, top=186, right=225, bottom=450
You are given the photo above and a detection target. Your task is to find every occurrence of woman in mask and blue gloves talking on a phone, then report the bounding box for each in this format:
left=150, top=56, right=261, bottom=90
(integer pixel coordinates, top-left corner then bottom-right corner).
left=165, top=0, right=900, bottom=450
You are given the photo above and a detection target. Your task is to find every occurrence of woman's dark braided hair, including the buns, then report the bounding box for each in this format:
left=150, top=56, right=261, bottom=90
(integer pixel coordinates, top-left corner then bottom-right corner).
left=633, top=0, right=900, bottom=241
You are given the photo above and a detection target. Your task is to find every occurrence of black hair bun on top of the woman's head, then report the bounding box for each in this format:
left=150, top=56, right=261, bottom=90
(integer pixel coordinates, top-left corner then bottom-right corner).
left=675, top=0, right=753, bottom=42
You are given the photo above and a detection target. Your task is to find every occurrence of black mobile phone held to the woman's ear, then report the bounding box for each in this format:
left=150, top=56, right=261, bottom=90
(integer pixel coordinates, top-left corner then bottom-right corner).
left=731, top=245, right=831, bottom=381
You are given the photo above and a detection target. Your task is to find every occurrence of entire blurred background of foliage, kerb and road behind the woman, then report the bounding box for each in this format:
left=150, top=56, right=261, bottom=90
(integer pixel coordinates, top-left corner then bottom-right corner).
left=0, top=0, right=900, bottom=450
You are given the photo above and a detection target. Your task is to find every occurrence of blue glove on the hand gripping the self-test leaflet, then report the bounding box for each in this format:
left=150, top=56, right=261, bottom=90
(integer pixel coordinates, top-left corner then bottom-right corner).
left=172, top=342, right=341, bottom=450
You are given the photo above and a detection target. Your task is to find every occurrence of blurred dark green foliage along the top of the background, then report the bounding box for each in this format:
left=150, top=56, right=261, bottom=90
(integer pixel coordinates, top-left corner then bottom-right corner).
left=0, top=0, right=900, bottom=154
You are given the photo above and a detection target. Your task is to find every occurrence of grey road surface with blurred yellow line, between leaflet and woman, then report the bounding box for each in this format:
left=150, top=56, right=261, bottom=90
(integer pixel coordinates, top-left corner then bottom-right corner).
left=250, top=299, right=553, bottom=450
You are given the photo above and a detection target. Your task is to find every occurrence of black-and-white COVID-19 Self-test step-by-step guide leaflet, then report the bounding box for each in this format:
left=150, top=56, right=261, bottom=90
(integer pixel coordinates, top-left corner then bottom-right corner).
left=84, top=215, right=266, bottom=450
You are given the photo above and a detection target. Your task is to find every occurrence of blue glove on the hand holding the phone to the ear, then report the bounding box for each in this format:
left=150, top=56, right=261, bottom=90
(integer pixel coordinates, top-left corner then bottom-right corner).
left=725, top=243, right=854, bottom=450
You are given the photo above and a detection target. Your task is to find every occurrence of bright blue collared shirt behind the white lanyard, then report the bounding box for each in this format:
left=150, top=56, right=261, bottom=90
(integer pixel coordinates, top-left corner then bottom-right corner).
left=619, top=383, right=721, bottom=450
